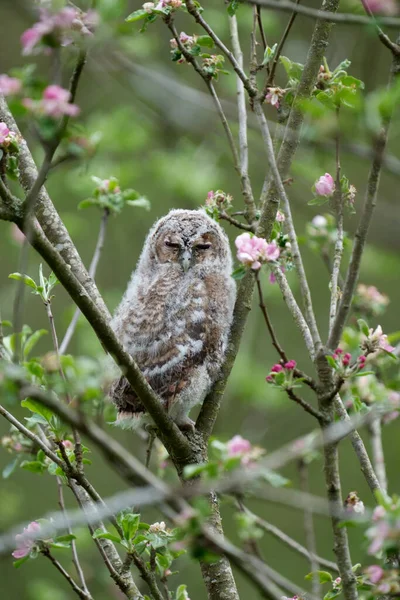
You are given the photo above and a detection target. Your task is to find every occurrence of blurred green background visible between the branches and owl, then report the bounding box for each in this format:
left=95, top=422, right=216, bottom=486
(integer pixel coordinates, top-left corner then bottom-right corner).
left=0, top=0, right=400, bottom=600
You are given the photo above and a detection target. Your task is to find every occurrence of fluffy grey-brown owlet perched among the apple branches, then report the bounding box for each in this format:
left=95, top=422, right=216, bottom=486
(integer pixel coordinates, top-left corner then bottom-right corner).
left=110, top=210, right=236, bottom=429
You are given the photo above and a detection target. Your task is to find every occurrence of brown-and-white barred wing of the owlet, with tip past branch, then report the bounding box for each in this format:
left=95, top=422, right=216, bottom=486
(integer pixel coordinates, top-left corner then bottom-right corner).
left=110, top=274, right=232, bottom=414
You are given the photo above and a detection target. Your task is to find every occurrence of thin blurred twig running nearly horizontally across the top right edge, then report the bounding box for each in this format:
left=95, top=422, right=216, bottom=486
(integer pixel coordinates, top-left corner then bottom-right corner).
left=247, top=0, right=400, bottom=29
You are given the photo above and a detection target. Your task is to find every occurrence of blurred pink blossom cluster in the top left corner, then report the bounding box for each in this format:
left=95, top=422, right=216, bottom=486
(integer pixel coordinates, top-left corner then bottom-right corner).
left=21, top=6, right=99, bottom=55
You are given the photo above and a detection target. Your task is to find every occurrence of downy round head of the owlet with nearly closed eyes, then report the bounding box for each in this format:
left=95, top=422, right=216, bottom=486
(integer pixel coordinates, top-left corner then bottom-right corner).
left=148, top=210, right=231, bottom=273
